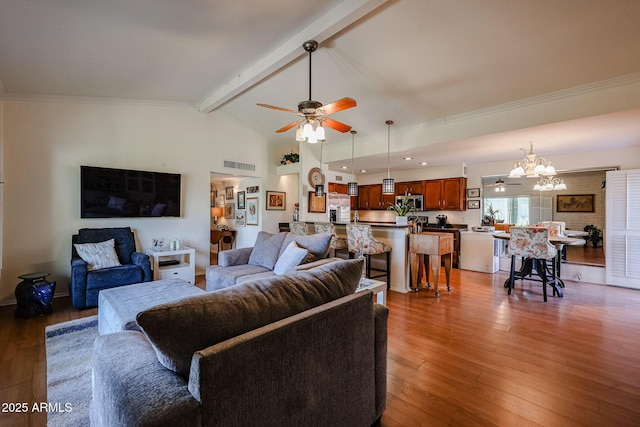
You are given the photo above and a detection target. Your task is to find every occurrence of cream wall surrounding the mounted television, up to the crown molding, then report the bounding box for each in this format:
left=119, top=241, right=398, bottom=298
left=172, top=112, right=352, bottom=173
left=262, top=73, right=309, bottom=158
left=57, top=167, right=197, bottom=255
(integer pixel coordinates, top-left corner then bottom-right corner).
left=0, top=100, right=274, bottom=304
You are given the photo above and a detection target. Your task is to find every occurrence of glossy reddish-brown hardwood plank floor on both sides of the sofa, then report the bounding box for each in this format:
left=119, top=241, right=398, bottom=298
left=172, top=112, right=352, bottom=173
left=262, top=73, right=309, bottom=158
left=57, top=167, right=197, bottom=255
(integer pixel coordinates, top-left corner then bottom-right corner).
left=0, top=269, right=640, bottom=427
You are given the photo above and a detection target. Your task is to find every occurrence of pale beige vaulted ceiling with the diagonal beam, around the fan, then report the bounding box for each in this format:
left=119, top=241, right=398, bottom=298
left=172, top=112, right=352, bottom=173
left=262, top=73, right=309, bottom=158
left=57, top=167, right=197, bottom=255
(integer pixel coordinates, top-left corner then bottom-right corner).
left=0, top=0, right=640, bottom=171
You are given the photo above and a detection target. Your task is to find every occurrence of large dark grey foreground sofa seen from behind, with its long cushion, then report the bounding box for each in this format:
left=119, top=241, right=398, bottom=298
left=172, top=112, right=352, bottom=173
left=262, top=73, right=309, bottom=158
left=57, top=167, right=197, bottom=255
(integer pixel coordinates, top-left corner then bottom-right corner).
left=91, top=260, right=388, bottom=427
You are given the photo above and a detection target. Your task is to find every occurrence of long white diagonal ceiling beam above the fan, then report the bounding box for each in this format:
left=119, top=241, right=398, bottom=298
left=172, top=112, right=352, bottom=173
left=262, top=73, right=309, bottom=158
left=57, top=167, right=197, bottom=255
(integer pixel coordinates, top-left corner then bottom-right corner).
left=198, top=0, right=388, bottom=113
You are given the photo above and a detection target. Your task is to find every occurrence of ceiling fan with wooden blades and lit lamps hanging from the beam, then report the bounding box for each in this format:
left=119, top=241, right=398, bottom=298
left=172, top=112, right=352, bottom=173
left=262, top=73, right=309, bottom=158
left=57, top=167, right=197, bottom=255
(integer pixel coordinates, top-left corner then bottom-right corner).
left=257, top=40, right=356, bottom=143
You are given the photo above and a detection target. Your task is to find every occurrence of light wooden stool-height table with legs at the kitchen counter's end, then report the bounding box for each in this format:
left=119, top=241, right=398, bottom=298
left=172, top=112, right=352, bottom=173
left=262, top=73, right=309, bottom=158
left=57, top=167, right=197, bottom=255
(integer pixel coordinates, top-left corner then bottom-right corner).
left=409, top=233, right=453, bottom=298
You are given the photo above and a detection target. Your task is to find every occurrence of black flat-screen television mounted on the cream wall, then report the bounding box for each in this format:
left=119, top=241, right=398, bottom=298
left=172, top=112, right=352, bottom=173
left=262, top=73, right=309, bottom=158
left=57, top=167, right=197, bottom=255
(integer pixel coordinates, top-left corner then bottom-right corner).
left=80, top=166, right=180, bottom=218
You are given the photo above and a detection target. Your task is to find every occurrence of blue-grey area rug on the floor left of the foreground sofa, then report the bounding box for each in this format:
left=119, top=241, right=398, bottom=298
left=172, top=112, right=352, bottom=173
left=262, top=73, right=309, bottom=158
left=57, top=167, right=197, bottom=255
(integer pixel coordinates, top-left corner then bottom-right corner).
left=45, top=316, right=98, bottom=427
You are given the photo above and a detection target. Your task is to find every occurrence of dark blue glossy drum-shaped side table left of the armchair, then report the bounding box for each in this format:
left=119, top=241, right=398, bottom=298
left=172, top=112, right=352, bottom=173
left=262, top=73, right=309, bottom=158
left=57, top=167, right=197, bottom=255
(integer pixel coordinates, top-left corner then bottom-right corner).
left=15, top=273, right=56, bottom=319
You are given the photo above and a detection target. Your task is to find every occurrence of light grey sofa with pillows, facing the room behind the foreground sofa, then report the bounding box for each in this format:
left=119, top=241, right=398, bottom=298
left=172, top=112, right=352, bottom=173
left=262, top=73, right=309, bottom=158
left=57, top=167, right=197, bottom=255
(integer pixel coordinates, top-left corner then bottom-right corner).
left=206, top=231, right=333, bottom=291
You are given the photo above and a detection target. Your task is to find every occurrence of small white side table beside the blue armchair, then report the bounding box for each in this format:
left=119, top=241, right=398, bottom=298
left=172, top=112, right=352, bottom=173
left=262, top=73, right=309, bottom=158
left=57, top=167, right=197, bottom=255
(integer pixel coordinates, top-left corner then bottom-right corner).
left=145, top=246, right=196, bottom=285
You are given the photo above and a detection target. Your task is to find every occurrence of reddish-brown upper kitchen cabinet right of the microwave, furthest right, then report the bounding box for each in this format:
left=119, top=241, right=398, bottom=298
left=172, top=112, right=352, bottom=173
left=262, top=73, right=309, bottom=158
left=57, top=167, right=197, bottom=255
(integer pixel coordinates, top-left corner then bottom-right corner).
left=424, top=178, right=467, bottom=211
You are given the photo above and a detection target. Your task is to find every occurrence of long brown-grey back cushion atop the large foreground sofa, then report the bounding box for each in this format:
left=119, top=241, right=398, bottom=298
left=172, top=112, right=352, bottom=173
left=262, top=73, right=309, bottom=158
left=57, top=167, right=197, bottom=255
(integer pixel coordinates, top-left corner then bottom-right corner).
left=136, top=260, right=362, bottom=378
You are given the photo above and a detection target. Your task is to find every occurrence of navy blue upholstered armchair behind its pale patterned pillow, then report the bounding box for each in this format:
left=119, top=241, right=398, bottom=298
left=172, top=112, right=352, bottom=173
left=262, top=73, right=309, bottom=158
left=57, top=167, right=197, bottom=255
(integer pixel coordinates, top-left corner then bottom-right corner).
left=69, top=227, right=153, bottom=309
